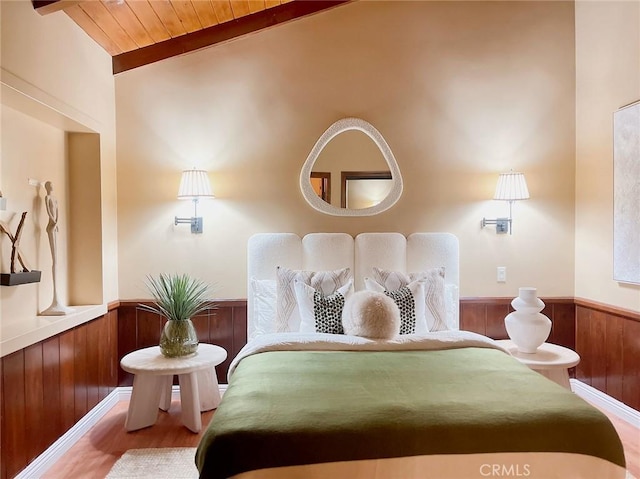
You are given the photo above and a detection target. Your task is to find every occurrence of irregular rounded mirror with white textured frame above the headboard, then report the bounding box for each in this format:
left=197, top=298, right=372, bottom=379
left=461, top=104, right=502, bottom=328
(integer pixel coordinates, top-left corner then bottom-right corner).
left=300, top=118, right=402, bottom=216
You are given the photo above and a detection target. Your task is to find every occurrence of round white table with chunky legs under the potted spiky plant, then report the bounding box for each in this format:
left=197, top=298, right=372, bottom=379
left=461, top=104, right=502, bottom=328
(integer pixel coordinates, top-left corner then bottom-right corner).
left=120, top=343, right=227, bottom=432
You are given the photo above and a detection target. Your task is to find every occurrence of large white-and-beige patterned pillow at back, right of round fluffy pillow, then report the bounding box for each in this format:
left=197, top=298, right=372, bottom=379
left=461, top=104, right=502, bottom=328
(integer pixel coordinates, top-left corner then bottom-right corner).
left=373, top=267, right=450, bottom=331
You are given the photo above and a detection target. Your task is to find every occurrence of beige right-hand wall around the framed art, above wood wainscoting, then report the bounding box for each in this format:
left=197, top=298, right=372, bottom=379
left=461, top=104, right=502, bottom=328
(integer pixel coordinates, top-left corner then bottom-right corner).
left=575, top=1, right=640, bottom=311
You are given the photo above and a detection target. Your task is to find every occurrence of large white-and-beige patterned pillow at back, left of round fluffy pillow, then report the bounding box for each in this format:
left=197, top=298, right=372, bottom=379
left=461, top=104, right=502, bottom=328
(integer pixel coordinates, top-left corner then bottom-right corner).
left=276, top=266, right=351, bottom=333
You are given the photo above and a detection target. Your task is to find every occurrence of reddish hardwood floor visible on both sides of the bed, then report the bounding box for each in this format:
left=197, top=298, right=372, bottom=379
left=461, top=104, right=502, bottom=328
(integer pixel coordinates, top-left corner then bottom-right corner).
left=43, top=401, right=640, bottom=479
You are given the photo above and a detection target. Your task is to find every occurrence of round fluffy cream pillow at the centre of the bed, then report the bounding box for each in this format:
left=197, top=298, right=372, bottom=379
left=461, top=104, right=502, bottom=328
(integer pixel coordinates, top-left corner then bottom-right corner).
left=342, top=290, right=400, bottom=339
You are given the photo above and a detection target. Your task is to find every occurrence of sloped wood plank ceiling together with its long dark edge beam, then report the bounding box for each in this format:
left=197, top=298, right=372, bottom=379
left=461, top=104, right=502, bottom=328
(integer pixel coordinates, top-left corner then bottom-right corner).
left=32, top=0, right=349, bottom=74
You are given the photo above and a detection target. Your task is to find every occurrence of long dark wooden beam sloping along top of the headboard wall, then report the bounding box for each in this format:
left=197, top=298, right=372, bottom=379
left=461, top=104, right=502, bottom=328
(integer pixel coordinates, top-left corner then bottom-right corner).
left=110, top=0, right=353, bottom=75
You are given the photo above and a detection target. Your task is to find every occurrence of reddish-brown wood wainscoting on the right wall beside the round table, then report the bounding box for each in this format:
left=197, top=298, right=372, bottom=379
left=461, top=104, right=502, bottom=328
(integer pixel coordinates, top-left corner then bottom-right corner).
left=575, top=298, right=640, bottom=410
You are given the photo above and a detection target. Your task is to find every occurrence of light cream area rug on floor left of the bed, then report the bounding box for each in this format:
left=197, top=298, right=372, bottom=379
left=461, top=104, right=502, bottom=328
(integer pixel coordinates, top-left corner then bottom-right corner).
left=107, top=447, right=198, bottom=479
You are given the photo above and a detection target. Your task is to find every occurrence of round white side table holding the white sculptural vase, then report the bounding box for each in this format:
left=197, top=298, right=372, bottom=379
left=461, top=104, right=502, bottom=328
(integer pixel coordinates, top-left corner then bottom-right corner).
left=496, top=339, right=580, bottom=390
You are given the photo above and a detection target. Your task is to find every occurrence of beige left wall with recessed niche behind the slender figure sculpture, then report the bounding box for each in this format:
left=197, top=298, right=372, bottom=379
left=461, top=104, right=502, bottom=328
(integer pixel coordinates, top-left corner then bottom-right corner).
left=0, top=0, right=118, bottom=323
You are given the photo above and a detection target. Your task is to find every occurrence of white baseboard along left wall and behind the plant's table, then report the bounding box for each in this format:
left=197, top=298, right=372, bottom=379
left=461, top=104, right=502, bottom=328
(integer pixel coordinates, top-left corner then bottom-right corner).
left=15, top=384, right=227, bottom=479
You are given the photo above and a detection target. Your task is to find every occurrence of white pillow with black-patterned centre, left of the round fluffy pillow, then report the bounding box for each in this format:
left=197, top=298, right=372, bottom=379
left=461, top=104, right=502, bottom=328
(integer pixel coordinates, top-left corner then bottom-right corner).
left=294, top=279, right=353, bottom=334
